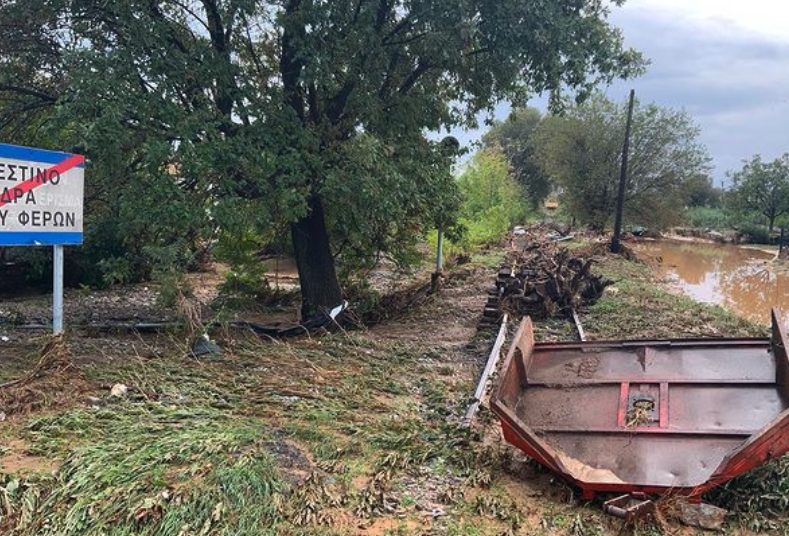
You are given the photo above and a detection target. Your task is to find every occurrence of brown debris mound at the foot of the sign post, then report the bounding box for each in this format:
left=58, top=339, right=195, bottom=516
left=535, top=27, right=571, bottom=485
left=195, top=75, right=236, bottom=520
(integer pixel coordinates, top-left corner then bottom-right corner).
left=0, top=335, right=85, bottom=415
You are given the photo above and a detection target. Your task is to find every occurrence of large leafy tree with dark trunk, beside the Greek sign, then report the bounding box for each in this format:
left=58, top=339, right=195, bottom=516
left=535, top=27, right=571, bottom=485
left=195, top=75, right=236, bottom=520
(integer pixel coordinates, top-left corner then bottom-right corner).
left=0, top=0, right=641, bottom=316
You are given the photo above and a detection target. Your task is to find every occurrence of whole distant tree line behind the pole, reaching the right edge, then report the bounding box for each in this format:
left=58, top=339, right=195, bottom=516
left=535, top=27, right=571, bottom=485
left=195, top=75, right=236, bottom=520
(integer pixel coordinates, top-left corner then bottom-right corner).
left=468, top=94, right=789, bottom=241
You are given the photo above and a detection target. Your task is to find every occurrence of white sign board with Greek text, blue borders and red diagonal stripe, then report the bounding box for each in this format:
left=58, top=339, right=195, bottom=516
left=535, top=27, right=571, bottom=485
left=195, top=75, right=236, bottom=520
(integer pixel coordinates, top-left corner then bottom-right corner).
left=0, top=144, right=85, bottom=246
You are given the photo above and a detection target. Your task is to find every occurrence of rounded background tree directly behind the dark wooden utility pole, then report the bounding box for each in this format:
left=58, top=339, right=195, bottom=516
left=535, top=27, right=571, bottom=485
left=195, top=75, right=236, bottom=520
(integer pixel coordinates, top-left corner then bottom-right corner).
left=533, top=94, right=710, bottom=231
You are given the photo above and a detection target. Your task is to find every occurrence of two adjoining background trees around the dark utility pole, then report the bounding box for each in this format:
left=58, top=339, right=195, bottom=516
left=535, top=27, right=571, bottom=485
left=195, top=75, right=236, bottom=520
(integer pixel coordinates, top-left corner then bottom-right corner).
left=470, top=94, right=719, bottom=231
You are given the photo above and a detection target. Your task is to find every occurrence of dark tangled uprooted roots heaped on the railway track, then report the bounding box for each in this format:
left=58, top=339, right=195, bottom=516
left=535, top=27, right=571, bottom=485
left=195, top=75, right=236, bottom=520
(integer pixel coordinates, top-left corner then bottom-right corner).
left=497, top=243, right=612, bottom=318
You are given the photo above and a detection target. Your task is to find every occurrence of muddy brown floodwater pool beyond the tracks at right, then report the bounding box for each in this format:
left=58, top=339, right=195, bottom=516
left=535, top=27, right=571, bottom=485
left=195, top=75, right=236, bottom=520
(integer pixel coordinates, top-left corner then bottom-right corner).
left=634, top=240, right=789, bottom=324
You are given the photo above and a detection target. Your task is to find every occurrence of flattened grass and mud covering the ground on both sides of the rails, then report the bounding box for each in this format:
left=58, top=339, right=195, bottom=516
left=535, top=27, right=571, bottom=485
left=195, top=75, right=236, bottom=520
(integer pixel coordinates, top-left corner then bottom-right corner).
left=0, top=240, right=789, bottom=536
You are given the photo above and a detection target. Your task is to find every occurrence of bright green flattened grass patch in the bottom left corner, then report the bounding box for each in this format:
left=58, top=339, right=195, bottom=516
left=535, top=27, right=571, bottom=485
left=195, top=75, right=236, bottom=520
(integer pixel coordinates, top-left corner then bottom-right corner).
left=4, top=403, right=284, bottom=536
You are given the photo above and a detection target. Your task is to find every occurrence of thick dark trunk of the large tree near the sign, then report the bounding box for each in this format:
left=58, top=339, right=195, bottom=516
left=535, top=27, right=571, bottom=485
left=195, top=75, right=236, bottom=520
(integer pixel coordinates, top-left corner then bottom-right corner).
left=290, top=196, right=342, bottom=321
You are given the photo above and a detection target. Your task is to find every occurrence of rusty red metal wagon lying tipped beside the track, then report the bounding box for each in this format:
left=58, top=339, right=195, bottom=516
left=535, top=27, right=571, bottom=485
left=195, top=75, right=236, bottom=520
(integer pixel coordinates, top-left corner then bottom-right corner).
left=491, top=311, right=789, bottom=498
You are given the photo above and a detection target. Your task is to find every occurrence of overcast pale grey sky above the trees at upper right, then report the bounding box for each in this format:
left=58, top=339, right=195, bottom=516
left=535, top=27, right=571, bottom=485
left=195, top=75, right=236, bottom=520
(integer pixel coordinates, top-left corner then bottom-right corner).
left=462, top=0, right=789, bottom=184
